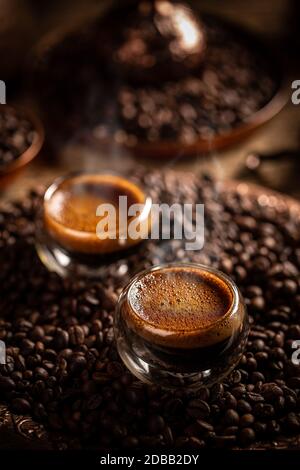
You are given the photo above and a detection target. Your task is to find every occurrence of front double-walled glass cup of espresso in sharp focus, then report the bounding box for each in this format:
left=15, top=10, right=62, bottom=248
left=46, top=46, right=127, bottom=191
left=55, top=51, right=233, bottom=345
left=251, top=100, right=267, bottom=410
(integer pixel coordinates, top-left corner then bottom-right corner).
left=115, top=263, right=249, bottom=388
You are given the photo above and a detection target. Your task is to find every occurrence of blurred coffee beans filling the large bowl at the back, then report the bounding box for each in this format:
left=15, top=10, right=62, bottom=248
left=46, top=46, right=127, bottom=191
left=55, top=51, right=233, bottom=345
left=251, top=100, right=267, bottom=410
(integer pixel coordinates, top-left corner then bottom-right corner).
left=37, top=17, right=279, bottom=147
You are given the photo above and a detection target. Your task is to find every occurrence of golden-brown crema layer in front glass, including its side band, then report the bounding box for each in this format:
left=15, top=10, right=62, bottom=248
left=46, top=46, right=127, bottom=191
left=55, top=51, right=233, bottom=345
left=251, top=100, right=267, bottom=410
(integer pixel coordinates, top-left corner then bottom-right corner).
left=125, top=267, right=244, bottom=348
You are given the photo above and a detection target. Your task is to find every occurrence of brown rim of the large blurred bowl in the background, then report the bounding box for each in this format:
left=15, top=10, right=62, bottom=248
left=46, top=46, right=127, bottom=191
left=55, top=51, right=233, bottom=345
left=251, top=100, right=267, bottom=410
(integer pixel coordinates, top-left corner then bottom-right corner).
left=32, top=13, right=289, bottom=159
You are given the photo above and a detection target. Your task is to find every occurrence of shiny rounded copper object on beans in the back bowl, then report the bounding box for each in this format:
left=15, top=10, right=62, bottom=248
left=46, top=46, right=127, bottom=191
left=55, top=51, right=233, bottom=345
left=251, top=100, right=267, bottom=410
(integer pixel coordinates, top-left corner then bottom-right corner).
left=94, top=0, right=206, bottom=85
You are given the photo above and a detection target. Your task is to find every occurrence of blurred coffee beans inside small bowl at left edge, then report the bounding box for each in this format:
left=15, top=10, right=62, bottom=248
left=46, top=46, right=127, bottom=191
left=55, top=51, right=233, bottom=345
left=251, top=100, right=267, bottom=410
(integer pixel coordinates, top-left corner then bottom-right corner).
left=0, top=106, right=34, bottom=171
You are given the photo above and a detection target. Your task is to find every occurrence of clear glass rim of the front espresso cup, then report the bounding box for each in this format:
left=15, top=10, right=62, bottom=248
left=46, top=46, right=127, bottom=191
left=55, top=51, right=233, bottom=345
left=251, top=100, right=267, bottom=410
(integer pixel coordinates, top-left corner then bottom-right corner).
left=117, top=261, right=241, bottom=333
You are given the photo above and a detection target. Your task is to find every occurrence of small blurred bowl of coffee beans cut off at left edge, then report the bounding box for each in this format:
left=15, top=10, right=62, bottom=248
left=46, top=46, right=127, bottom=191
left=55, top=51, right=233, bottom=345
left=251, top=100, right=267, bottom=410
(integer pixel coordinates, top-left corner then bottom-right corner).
left=0, top=104, right=44, bottom=189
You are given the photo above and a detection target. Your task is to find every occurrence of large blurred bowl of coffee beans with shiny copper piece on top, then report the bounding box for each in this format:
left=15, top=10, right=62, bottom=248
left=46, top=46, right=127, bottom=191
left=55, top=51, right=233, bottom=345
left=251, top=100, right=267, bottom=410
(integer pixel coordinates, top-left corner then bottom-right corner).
left=30, top=1, right=288, bottom=159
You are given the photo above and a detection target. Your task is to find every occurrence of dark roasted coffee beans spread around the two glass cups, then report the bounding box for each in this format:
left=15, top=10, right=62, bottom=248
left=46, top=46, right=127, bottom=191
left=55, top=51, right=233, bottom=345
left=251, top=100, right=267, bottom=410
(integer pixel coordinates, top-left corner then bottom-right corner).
left=0, top=171, right=300, bottom=449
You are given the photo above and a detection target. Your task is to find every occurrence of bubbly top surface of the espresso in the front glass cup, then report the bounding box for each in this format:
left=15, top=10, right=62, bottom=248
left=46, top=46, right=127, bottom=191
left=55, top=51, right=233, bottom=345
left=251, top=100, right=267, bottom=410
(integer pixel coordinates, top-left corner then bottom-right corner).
left=130, top=268, right=232, bottom=333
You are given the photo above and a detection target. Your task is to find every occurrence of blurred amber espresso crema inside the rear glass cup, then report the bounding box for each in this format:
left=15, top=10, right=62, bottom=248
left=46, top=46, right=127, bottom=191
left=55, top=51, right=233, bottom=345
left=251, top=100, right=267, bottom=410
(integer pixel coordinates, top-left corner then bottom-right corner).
left=44, top=174, right=149, bottom=254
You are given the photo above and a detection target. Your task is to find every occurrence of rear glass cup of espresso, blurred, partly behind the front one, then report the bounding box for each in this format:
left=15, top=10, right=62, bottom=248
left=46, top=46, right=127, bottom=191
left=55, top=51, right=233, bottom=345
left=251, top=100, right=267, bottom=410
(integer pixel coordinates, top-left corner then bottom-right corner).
left=36, top=173, right=152, bottom=277
